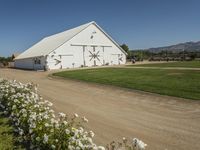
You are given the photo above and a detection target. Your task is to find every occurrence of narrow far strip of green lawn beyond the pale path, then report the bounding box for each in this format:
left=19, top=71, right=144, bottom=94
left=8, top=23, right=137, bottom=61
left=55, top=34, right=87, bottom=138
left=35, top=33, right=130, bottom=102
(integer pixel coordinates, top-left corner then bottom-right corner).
left=129, top=61, right=200, bottom=68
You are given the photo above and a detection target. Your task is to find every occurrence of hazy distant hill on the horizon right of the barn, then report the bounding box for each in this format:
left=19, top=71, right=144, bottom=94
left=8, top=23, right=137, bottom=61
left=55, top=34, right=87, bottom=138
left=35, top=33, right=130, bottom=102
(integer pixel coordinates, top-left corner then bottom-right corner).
left=146, top=41, right=200, bottom=53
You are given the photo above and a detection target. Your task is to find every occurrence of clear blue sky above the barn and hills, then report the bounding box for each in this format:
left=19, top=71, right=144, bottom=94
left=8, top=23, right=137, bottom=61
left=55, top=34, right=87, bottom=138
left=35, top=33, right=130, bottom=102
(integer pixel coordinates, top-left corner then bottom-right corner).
left=0, top=0, right=200, bottom=56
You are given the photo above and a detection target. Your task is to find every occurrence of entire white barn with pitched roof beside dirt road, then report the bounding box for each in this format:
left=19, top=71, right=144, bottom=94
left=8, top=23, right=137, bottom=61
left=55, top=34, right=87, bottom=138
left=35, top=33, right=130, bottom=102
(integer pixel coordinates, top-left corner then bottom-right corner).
left=15, top=22, right=126, bottom=70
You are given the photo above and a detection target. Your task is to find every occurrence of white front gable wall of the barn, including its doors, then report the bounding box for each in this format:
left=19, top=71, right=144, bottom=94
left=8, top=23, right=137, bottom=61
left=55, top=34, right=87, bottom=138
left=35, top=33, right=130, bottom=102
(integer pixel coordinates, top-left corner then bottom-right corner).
left=47, top=23, right=126, bottom=69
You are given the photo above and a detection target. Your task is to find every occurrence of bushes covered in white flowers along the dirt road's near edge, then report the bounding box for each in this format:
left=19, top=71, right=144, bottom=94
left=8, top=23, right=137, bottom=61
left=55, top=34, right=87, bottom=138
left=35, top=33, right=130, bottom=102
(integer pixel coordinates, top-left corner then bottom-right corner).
left=0, top=79, right=146, bottom=150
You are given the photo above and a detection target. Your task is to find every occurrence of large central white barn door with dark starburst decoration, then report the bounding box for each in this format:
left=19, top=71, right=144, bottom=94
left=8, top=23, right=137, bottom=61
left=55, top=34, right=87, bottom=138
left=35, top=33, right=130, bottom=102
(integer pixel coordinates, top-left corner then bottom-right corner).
left=84, top=46, right=103, bottom=66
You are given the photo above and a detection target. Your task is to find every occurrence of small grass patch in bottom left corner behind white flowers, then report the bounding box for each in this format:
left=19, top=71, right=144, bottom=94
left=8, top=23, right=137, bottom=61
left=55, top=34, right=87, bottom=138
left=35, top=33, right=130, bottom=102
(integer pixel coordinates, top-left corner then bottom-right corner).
left=0, top=111, right=22, bottom=150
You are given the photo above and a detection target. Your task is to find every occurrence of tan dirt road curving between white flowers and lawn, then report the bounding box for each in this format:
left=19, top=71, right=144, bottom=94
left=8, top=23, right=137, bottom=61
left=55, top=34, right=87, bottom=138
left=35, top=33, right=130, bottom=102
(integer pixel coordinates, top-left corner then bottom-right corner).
left=0, top=69, right=200, bottom=150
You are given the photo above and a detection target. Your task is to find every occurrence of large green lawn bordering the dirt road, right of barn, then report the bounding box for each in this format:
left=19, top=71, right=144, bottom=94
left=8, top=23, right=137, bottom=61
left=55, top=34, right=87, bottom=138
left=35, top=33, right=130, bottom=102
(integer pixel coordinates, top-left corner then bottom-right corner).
left=53, top=68, right=200, bottom=100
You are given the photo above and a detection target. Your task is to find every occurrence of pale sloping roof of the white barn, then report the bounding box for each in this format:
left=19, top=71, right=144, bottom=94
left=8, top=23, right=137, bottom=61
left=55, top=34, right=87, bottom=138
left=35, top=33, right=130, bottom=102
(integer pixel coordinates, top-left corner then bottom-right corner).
left=15, top=21, right=126, bottom=60
